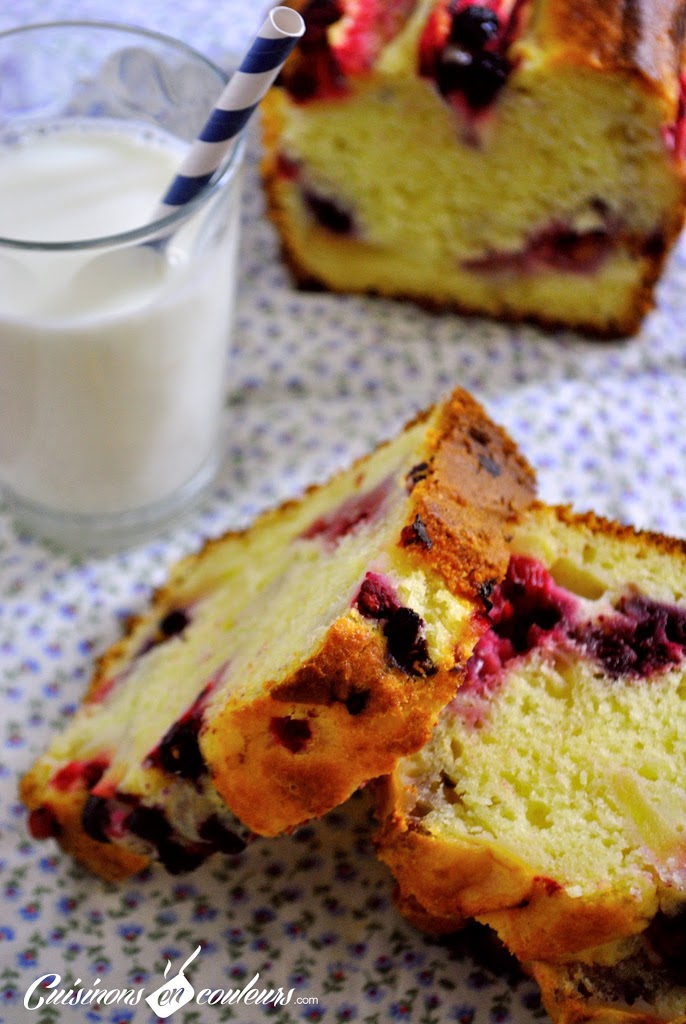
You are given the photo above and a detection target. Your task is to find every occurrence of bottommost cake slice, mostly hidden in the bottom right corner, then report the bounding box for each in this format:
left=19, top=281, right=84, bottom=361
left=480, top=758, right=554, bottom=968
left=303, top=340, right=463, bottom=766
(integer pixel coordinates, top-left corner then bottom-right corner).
left=530, top=911, right=686, bottom=1024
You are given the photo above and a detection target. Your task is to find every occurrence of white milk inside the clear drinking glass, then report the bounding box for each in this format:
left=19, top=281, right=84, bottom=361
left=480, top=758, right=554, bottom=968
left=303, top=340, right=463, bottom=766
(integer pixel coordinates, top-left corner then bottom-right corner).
left=0, top=121, right=240, bottom=516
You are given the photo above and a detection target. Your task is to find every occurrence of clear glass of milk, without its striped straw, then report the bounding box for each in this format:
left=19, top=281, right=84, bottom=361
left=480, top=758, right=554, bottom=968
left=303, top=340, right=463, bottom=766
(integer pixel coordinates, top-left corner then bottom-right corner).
left=0, top=22, right=244, bottom=551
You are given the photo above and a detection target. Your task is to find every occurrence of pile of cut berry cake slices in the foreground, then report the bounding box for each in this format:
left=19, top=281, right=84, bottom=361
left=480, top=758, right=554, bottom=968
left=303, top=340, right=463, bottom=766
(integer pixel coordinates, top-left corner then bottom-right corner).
left=22, top=391, right=686, bottom=1024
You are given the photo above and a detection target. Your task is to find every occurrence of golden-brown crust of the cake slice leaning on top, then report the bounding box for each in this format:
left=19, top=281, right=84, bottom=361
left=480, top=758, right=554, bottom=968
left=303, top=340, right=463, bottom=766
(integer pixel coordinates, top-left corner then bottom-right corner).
left=202, top=391, right=534, bottom=836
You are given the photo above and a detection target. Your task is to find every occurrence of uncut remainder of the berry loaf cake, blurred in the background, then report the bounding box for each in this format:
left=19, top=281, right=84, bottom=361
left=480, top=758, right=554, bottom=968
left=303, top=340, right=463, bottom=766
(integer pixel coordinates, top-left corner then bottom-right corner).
left=263, top=0, right=686, bottom=337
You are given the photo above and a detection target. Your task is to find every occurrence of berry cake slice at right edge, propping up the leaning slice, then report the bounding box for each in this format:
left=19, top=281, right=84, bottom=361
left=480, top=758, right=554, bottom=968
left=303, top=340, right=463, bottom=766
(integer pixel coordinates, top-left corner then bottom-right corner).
left=378, top=506, right=686, bottom=963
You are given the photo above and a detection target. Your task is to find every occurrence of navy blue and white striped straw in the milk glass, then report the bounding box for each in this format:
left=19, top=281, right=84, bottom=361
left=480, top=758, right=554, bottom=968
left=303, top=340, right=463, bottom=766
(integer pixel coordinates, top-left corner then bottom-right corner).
left=156, top=7, right=305, bottom=218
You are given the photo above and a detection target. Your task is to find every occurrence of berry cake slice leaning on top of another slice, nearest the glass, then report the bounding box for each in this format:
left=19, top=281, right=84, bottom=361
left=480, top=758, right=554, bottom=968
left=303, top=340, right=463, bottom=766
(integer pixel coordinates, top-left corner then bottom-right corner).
left=22, top=391, right=533, bottom=879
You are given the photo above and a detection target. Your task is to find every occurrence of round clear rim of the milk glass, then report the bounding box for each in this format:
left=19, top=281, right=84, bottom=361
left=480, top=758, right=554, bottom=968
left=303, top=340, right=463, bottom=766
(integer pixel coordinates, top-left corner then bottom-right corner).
left=0, top=18, right=246, bottom=252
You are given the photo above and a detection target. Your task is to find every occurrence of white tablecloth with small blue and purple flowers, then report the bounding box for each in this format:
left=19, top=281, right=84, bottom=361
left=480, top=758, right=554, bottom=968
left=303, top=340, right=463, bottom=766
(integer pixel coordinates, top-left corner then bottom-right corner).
left=0, top=0, right=686, bottom=1024
